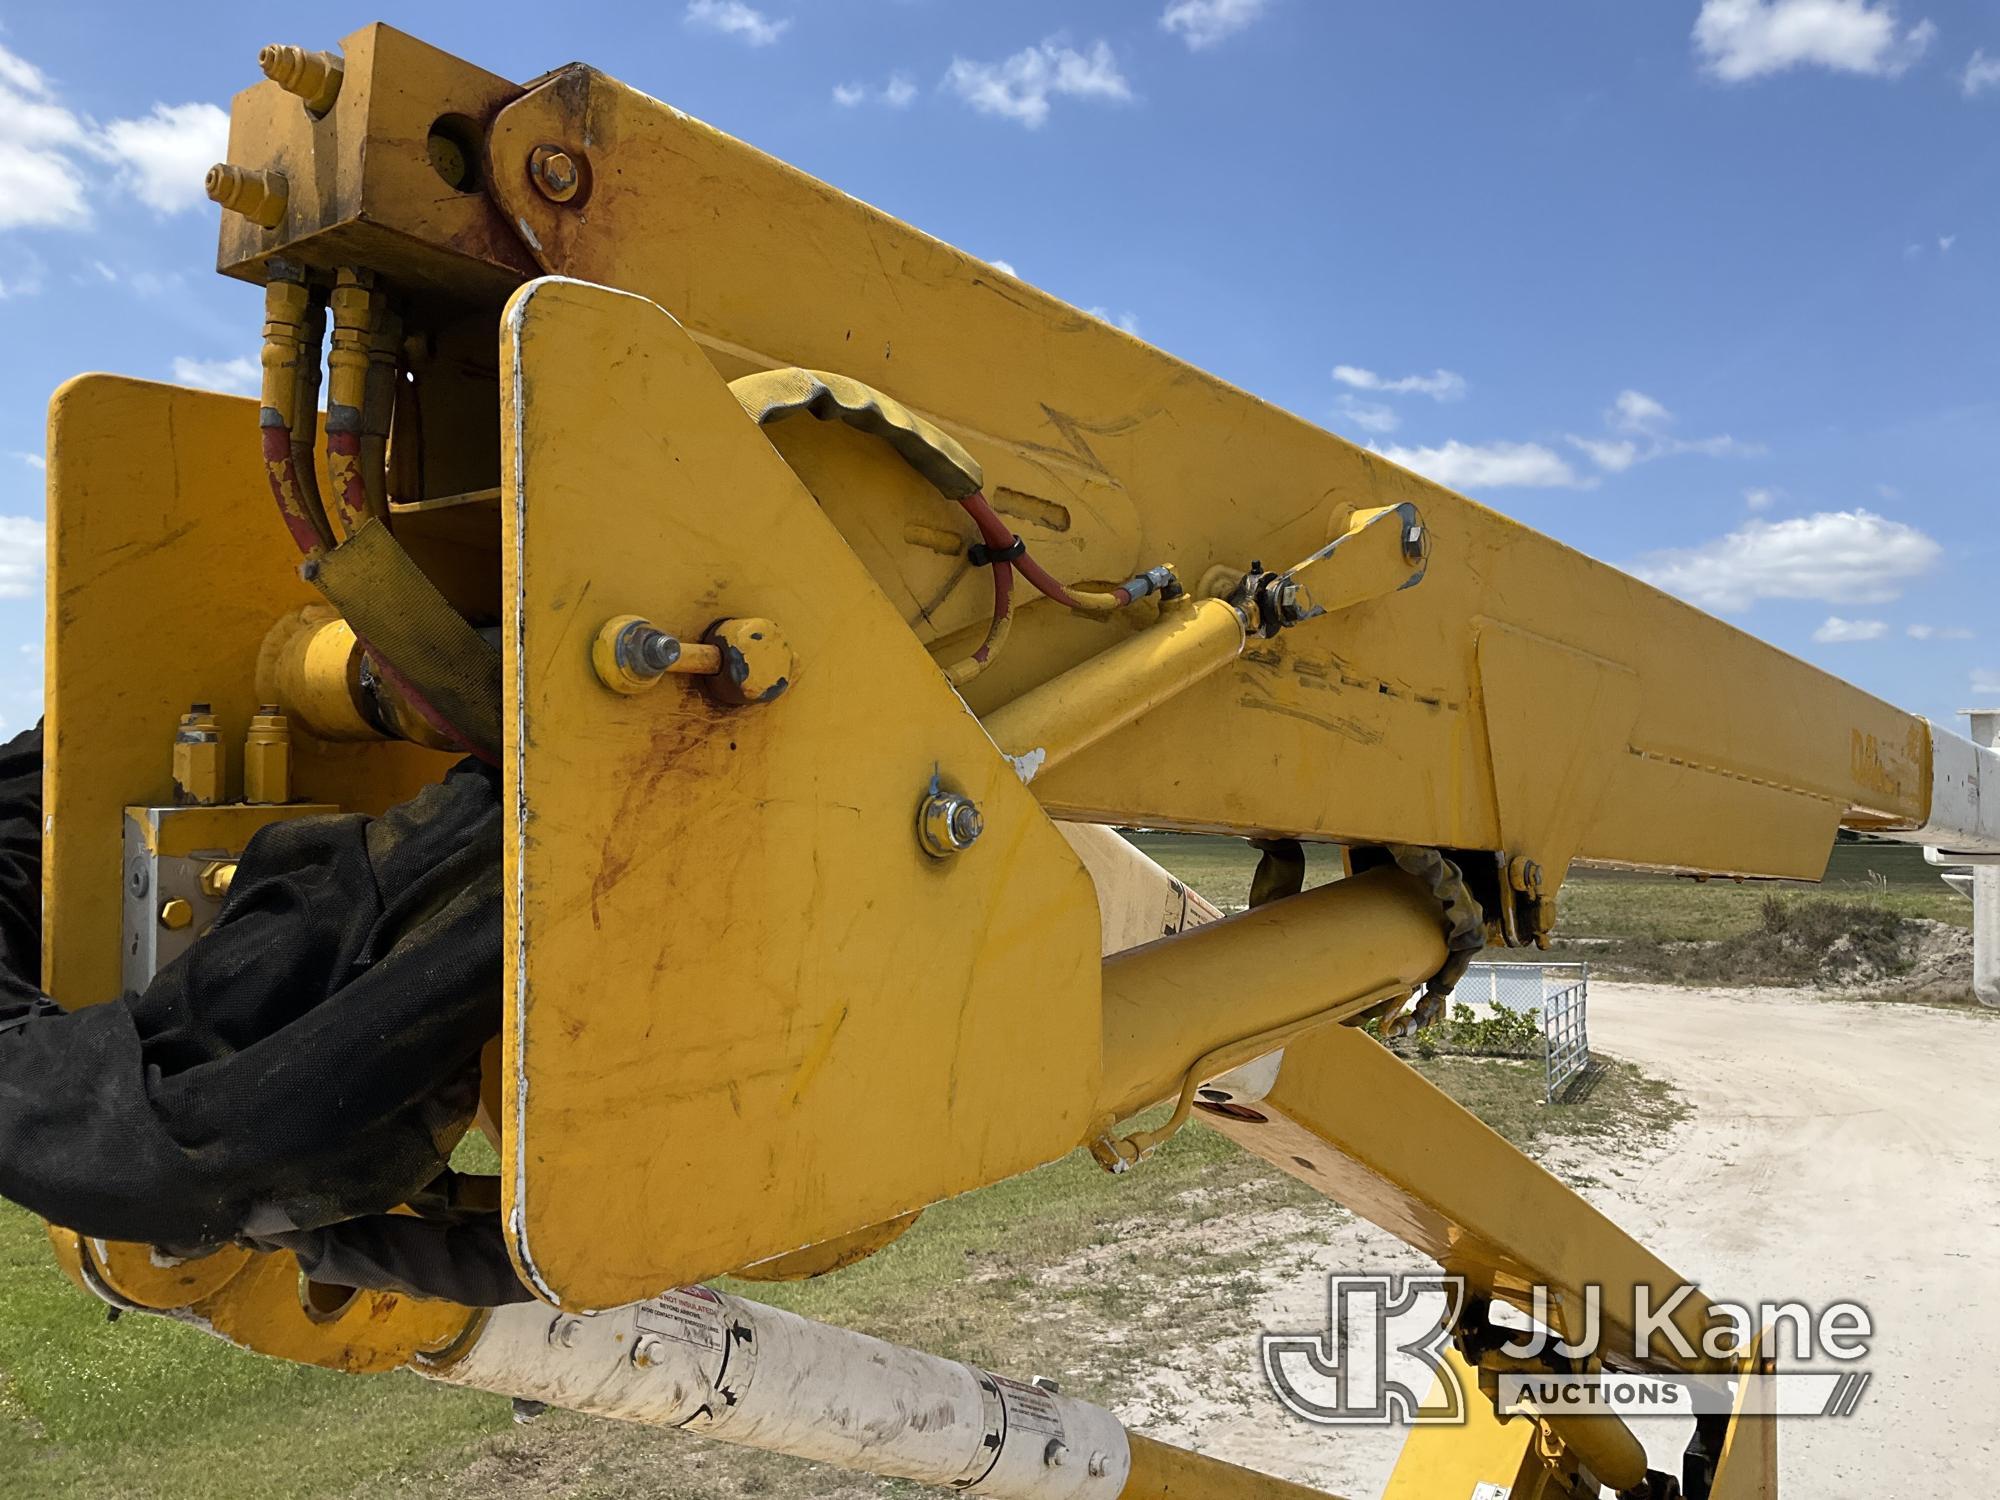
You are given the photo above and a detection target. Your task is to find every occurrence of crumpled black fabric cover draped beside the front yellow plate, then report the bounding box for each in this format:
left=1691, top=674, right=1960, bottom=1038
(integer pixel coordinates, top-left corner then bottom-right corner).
left=0, top=728, right=526, bottom=1302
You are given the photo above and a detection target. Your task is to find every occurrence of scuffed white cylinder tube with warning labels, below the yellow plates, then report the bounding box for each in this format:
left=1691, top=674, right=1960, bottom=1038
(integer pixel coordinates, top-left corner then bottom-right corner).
left=420, top=1286, right=1132, bottom=1500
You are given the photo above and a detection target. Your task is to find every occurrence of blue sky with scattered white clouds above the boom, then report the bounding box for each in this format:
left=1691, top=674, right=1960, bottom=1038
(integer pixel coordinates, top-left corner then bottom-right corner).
left=0, top=0, right=2000, bottom=740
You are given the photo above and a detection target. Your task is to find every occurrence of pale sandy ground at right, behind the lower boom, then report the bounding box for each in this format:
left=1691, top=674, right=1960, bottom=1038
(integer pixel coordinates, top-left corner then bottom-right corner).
left=1120, top=982, right=2000, bottom=1500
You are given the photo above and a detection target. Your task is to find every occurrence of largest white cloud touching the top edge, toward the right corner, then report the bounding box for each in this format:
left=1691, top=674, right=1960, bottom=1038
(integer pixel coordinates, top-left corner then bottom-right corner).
left=1694, top=0, right=1938, bottom=84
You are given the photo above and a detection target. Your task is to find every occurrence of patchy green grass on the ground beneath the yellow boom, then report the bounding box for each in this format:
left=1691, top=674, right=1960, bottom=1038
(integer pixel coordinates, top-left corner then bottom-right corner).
left=0, top=1058, right=1672, bottom=1500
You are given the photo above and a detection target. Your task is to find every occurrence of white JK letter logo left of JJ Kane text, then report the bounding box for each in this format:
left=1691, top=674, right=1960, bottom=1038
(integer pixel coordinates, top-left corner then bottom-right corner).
left=1258, top=1274, right=1466, bottom=1426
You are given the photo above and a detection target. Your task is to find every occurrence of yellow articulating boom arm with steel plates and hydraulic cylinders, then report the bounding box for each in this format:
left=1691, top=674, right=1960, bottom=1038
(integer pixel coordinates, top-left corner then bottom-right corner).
left=31, top=26, right=2000, bottom=1496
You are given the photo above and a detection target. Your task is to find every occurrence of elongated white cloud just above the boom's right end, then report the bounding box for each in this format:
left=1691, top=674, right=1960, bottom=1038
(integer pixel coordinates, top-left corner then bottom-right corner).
left=1630, top=510, right=1944, bottom=610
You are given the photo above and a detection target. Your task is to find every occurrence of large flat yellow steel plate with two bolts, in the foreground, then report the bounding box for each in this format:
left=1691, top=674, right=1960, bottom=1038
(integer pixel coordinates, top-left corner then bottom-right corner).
left=502, top=280, right=1102, bottom=1308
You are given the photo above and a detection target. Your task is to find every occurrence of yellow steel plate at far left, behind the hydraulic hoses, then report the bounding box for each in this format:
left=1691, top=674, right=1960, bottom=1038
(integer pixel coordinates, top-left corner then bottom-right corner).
left=42, top=376, right=454, bottom=1006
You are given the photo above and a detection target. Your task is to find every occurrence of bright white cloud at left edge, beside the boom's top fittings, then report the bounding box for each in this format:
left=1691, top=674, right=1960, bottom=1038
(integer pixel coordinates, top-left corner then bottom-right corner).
left=0, top=48, right=230, bottom=230
